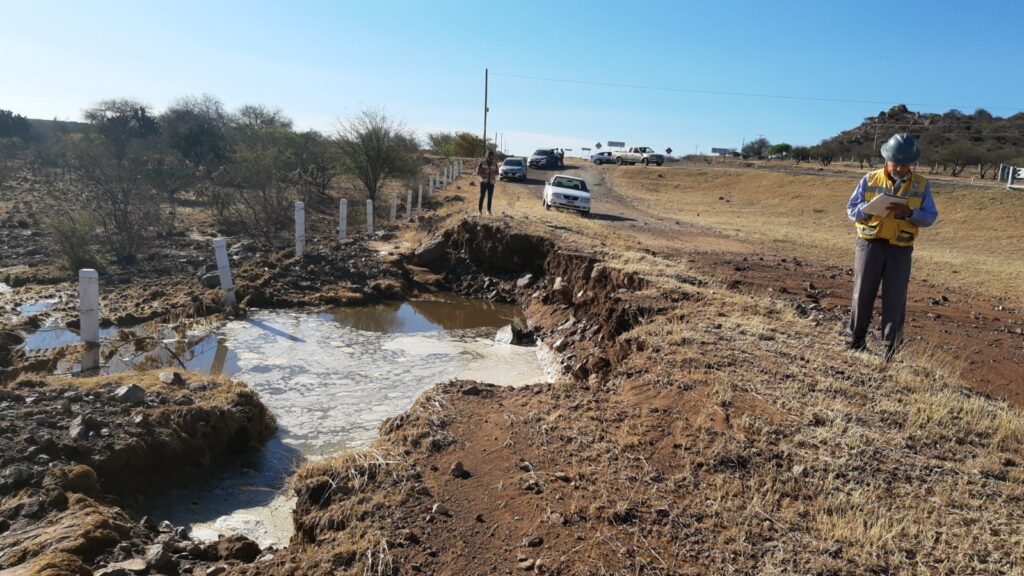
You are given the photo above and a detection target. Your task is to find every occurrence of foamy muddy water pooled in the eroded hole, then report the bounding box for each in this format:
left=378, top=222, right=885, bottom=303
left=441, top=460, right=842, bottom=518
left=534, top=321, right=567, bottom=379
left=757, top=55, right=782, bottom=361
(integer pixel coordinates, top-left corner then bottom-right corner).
left=135, top=298, right=546, bottom=546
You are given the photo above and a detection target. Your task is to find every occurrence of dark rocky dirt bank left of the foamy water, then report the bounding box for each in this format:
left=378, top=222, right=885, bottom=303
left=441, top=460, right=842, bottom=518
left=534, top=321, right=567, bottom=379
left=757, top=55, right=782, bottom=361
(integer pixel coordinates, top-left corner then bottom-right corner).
left=0, top=371, right=275, bottom=576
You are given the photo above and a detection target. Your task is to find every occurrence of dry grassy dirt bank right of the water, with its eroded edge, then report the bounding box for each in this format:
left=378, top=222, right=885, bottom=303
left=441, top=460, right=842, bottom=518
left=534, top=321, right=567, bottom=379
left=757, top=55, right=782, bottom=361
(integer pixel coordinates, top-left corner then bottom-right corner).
left=249, top=220, right=1024, bottom=575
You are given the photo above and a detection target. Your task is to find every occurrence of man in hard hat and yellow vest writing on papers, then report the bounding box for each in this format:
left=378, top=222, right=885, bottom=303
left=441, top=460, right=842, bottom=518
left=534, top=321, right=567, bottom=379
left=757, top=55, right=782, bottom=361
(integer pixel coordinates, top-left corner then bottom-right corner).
left=846, top=133, right=939, bottom=360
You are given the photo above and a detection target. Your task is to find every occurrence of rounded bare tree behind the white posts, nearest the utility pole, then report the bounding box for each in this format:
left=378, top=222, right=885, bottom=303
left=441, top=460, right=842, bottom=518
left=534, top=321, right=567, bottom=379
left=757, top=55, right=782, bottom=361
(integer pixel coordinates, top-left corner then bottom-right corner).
left=336, top=110, right=419, bottom=200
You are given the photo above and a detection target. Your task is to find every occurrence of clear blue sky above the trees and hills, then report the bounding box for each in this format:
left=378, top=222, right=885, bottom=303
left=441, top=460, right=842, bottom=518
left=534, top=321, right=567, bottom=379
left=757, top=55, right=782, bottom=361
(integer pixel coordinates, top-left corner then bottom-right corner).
left=0, top=0, right=1024, bottom=154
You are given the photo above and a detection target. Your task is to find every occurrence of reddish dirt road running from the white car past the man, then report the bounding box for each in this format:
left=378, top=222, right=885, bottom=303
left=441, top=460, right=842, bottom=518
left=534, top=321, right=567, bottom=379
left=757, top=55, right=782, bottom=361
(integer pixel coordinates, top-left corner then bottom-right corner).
left=497, top=158, right=1024, bottom=407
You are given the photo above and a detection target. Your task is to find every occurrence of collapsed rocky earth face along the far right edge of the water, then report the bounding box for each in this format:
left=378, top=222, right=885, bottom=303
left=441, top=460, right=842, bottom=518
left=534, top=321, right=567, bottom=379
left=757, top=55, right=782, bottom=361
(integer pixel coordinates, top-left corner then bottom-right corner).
left=410, top=219, right=667, bottom=380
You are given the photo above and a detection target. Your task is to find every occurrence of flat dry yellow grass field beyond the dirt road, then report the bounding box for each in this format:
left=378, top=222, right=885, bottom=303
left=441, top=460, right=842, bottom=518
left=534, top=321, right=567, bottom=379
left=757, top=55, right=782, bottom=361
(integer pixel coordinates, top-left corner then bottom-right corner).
left=607, top=166, right=1024, bottom=302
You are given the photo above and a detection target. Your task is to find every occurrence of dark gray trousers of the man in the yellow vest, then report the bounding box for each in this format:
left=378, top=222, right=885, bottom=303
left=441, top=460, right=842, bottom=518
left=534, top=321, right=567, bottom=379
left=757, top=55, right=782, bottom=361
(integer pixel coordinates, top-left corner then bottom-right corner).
left=850, top=238, right=913, bottom=346
